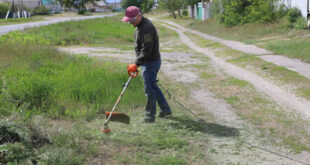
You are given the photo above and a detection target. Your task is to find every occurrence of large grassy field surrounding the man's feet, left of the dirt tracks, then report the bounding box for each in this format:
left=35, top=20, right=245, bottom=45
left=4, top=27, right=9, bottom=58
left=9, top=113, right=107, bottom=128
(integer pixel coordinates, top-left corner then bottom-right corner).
left=0, top=16, right=213, bottom=165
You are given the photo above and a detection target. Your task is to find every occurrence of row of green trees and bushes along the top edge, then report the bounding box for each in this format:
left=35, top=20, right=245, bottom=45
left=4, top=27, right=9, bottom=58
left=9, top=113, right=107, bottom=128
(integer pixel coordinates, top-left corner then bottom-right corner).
left=58, top=0, right=301, bottom=26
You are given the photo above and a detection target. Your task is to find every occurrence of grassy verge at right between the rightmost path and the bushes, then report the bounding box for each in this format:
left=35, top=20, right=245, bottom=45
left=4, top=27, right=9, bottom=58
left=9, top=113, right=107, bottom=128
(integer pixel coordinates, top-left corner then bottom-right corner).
left=166, top=15, right=310, bottom=63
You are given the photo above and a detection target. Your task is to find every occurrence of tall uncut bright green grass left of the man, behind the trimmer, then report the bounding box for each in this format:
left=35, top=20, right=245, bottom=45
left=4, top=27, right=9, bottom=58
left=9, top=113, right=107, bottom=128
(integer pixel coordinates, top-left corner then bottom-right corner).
left=0, top=43, right=145, bottom=118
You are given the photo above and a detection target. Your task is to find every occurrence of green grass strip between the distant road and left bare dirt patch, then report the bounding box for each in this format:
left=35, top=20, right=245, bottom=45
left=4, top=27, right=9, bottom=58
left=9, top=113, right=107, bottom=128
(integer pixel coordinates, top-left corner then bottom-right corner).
left=0, top=16, right=134, bottom=49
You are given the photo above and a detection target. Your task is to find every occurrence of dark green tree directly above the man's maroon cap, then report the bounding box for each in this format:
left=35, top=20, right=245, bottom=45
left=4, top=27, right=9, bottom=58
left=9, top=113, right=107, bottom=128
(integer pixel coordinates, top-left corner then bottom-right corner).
left=122, top=0, right=154, bottom=13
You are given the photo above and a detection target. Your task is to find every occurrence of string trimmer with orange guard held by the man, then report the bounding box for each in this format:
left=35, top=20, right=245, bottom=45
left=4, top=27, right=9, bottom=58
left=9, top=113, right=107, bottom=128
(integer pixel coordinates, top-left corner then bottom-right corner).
left=101, top=70, right=139, bottom=134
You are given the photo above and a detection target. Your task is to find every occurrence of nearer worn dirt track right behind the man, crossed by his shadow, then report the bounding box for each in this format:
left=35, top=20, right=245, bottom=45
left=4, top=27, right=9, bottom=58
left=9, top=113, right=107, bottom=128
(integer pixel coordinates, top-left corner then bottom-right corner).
left=161, top=53, right=310, bottom=165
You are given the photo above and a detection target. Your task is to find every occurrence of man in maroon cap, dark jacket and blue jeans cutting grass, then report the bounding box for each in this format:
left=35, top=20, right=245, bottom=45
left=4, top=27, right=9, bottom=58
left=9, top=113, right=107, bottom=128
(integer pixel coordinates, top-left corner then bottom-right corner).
left=122, top=6, right=172, bottom=123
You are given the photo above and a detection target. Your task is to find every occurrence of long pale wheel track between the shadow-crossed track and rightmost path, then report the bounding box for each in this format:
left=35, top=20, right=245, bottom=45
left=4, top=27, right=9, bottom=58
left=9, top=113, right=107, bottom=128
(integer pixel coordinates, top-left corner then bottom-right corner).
left=162, top=21, right=310, bottom=120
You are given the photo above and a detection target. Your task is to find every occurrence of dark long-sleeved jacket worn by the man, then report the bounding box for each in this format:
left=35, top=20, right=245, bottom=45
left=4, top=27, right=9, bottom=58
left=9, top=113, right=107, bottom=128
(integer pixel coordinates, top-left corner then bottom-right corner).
left=135, top=17, right=160, bottom=66
